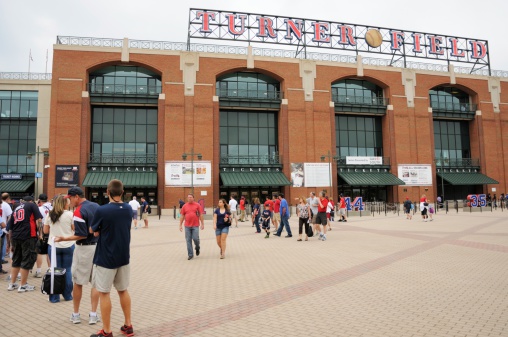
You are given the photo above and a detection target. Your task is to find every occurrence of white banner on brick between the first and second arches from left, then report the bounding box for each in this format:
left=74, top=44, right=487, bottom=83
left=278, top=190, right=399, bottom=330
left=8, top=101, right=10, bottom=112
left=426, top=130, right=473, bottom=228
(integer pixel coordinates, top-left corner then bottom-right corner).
left=165, top=161, right=212, bottom=187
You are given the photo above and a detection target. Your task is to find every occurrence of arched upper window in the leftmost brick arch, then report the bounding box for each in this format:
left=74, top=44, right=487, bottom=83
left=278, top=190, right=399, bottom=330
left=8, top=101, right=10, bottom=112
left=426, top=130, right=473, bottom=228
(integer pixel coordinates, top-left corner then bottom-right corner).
left=89, top=66, right=161, bottom=96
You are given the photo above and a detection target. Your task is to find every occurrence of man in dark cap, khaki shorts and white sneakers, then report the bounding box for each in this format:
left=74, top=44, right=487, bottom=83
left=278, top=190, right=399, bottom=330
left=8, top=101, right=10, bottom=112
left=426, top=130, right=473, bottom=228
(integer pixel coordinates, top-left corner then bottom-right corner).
left=55, top=186, right=100, bottom=324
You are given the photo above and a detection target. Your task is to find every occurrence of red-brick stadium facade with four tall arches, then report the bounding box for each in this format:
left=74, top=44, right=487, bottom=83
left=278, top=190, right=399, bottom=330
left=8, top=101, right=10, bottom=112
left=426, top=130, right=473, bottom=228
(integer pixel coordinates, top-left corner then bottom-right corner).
left=41, top=39, right=508, bottom=210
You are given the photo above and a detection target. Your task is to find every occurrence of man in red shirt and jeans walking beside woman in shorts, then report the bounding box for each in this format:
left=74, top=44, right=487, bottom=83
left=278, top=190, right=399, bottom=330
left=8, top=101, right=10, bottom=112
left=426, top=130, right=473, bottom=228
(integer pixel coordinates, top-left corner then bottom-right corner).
left=180, top=194, right=205, bottom=260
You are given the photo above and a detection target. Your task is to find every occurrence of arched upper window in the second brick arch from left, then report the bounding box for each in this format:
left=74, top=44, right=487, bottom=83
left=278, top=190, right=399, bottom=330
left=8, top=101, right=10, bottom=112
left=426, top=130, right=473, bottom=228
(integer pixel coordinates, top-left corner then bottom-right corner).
left=216, top=72, right=282, bottom=100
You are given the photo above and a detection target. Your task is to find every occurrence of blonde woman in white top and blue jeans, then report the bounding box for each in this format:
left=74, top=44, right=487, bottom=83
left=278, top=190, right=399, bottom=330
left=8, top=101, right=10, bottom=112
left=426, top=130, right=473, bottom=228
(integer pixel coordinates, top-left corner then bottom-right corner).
left=43, top=195, right=74, bottom=303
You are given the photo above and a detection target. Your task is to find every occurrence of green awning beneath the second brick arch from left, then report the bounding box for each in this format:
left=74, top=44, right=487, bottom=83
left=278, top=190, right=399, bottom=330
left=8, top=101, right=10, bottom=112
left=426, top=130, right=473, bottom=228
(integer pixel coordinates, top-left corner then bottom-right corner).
left=220, top=172, right=291, bottom=187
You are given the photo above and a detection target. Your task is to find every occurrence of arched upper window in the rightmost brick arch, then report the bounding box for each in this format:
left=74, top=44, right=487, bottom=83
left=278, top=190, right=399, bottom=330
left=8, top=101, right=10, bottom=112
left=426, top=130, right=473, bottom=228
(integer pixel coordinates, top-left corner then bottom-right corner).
left=429, top=86, right=476, bottom=113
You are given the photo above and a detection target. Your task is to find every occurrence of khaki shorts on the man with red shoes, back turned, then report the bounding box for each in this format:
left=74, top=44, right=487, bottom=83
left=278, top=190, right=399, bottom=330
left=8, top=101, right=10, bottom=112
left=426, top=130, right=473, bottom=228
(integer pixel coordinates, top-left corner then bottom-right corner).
left=92, top=265, right=131, bottom=293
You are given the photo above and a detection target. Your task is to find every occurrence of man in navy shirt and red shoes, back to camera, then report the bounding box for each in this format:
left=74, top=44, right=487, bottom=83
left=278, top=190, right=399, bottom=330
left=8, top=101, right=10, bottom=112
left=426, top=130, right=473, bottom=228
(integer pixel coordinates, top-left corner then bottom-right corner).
left=90, top=179, right=134, bottom=337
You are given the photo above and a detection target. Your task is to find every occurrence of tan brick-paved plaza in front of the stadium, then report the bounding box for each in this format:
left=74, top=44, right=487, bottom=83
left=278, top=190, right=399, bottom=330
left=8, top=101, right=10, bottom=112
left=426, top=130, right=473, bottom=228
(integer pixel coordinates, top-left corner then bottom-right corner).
left=0, top=210, right=508, bottom=337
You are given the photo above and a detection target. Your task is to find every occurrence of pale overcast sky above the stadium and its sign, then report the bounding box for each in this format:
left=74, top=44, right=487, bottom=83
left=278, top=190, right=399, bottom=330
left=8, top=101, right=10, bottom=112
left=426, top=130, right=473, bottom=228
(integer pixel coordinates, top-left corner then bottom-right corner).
left=0, top=0, right=508, bottom=72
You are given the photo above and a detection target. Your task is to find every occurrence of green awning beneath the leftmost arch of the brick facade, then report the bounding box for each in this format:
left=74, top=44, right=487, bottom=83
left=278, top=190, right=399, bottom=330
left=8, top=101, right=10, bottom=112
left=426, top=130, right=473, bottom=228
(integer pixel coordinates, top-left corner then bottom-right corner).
left=83, top=172, right=157, bottom=188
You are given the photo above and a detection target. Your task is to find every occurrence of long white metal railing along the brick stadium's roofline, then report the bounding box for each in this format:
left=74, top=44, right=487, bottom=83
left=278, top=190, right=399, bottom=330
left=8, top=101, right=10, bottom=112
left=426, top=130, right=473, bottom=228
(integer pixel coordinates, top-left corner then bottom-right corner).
left=56, top=36, right=508, bottom=78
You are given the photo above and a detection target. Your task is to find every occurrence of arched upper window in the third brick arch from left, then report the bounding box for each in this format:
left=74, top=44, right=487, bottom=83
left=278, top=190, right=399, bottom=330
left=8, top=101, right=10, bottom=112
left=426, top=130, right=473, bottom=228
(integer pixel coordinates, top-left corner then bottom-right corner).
left=332, top=79, right=387, bottom=106
